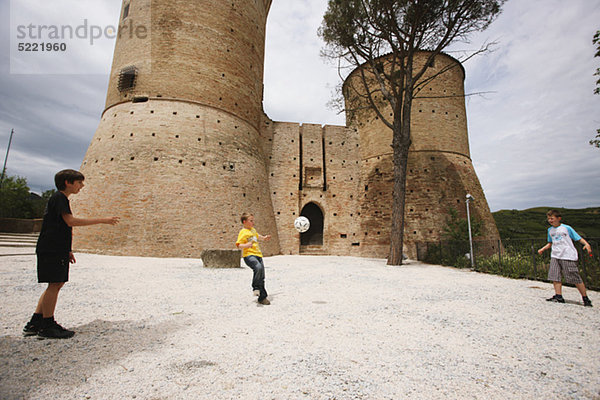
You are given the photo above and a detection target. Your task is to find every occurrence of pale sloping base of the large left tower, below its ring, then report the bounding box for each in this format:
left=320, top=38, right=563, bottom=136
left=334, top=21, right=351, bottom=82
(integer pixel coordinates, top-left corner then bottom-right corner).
left=72, top=100, right=279, bottom=257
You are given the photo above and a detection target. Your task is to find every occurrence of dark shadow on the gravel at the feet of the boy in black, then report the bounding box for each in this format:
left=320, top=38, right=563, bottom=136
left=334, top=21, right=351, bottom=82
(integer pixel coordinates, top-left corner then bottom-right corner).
left=0, top=320, right=181, bottom=400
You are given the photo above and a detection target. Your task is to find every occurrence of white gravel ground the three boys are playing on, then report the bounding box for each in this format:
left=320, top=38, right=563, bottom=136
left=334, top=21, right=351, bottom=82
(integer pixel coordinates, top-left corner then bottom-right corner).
left=0, top=254, right=600, bottom=400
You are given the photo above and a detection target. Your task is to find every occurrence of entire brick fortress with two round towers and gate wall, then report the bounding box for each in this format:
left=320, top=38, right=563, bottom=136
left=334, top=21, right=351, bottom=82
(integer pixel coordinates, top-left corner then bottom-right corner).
left=72, top=0, right=499, bottom=258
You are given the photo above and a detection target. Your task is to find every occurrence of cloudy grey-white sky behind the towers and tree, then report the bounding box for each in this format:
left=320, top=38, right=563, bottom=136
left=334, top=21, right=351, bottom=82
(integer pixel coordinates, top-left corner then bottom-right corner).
left=0, top=0, right=600, bottom=211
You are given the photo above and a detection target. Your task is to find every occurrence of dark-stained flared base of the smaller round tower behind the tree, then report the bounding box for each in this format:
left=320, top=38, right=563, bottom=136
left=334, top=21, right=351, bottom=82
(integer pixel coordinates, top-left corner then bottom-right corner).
left=361, top=151, right=499, bottom=257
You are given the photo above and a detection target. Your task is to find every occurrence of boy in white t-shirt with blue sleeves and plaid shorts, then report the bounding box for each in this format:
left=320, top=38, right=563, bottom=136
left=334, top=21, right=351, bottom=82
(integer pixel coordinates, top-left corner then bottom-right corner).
left=538, top=210, right=592, bottom=307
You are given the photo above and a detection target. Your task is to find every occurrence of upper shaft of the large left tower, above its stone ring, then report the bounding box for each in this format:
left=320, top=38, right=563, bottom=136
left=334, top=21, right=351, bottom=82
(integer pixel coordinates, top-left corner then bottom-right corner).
left=106, top=0, right=268, bottom=129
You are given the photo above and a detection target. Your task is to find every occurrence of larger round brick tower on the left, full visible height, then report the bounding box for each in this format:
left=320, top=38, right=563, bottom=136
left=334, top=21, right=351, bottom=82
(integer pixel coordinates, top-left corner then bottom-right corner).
left=72, top=0, right=279, bottom=257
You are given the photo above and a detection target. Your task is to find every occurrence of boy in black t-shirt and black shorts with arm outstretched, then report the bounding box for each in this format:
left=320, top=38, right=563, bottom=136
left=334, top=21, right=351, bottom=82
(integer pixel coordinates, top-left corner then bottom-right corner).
left=23, top=169, right=119, bottom=339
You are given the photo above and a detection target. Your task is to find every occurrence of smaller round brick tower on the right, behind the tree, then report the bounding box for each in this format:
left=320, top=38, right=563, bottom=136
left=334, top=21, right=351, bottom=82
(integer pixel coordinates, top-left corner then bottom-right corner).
left=344, top=51, right=499, bottom=257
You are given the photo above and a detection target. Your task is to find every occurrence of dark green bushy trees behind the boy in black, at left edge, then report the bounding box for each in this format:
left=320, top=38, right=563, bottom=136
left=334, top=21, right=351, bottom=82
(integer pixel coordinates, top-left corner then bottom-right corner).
left=0, top=176, right=49, bottom=218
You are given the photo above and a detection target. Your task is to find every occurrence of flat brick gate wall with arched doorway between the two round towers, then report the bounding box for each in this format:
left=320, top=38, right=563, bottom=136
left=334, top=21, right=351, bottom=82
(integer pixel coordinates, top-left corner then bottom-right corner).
left=269, top=121, right=362, bottom=255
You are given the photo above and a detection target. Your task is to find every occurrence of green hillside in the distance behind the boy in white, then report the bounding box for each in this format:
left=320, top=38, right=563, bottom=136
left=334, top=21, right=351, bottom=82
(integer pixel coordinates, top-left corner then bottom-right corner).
left=492, top=207, right=600, bottom=239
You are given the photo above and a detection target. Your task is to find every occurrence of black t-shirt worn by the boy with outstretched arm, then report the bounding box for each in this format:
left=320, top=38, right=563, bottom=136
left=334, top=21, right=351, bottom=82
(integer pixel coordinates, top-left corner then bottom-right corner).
left=35, top=192, right=73, bottom=254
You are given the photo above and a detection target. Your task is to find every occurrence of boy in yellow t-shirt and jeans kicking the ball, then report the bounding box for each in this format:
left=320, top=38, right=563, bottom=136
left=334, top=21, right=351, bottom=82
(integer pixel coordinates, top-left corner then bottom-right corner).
left=235, top=213, right=271, bottom=305
